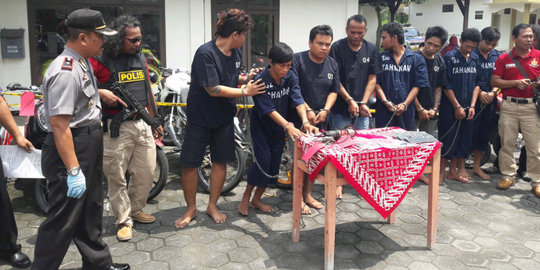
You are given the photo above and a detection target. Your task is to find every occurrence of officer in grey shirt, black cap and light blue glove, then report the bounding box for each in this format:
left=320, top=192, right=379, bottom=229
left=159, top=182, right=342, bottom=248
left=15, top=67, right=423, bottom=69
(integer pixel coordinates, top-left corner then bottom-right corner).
left=32, top=9, right=130, bottom=269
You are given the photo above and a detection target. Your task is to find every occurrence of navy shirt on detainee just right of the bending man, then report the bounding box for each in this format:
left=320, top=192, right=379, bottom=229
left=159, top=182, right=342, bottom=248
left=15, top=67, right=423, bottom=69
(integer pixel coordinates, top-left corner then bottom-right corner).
left=292, top=51, right=340, bottom=110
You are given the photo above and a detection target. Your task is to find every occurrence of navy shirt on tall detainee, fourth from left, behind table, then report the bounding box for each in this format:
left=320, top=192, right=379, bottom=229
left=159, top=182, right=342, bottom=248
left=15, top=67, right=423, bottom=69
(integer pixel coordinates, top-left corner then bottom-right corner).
left=330, top=38, right=380, bottom=115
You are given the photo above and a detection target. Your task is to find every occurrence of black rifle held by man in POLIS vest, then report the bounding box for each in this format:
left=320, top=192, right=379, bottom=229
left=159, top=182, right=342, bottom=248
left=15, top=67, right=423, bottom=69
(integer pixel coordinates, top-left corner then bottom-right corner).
left=109, top=82, right=163, bottom=138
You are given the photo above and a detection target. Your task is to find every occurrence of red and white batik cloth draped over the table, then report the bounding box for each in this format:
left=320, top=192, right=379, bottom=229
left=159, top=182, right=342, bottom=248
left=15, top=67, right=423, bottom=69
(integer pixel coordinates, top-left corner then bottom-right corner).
left=300, top=128, right=440, bottom=218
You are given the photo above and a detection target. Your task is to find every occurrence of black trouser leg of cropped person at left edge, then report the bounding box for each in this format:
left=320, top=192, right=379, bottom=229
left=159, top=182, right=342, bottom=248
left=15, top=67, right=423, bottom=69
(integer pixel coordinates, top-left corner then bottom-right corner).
left=0, top=156, right=18, bottom=254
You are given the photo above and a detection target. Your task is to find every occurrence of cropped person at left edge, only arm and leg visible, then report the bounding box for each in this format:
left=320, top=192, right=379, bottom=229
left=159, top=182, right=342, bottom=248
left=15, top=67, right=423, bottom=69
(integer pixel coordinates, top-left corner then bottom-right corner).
left=0, top=95, right=34, bottom=268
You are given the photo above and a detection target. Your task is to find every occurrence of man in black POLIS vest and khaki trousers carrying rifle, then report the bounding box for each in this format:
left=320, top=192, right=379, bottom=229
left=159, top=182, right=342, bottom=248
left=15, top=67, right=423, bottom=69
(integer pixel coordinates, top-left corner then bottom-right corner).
left=90, top=15, right=163, bottom=241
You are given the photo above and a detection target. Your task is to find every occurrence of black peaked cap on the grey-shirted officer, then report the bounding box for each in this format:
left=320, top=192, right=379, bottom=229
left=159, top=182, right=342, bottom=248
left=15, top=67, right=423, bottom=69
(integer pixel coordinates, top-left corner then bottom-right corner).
left=66, top=9, right=118, bottom=36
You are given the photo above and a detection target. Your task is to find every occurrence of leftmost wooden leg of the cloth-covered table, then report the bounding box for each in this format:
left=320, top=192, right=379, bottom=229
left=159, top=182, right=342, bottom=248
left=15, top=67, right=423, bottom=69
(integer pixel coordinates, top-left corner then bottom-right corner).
left=292, top=140, right=304, bottom=242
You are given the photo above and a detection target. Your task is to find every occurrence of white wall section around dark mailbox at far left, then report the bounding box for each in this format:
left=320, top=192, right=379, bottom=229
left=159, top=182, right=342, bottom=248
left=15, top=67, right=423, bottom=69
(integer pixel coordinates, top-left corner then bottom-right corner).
left=0, top=0, right=31, bottom=94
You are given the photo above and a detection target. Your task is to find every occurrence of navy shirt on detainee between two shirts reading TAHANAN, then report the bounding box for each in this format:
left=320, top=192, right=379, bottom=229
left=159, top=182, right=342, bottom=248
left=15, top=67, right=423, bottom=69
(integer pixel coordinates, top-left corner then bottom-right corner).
left=416, top=51, right=447, bottom=110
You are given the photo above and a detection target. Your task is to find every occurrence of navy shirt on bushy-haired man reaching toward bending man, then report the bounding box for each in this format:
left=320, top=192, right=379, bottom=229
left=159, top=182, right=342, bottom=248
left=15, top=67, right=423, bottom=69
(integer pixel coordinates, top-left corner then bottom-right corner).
left=187, top=40, right=242, bottom=127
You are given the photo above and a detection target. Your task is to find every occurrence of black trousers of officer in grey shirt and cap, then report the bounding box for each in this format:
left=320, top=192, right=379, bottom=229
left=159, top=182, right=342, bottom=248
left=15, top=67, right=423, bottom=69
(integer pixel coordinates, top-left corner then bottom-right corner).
left=32, top=129, right=112, bottom=269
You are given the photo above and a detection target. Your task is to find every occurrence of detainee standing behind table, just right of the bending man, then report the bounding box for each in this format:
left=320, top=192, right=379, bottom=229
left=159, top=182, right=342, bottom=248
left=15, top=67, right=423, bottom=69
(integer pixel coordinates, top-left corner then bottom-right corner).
left=291, top=25, right=340, bottom=214
